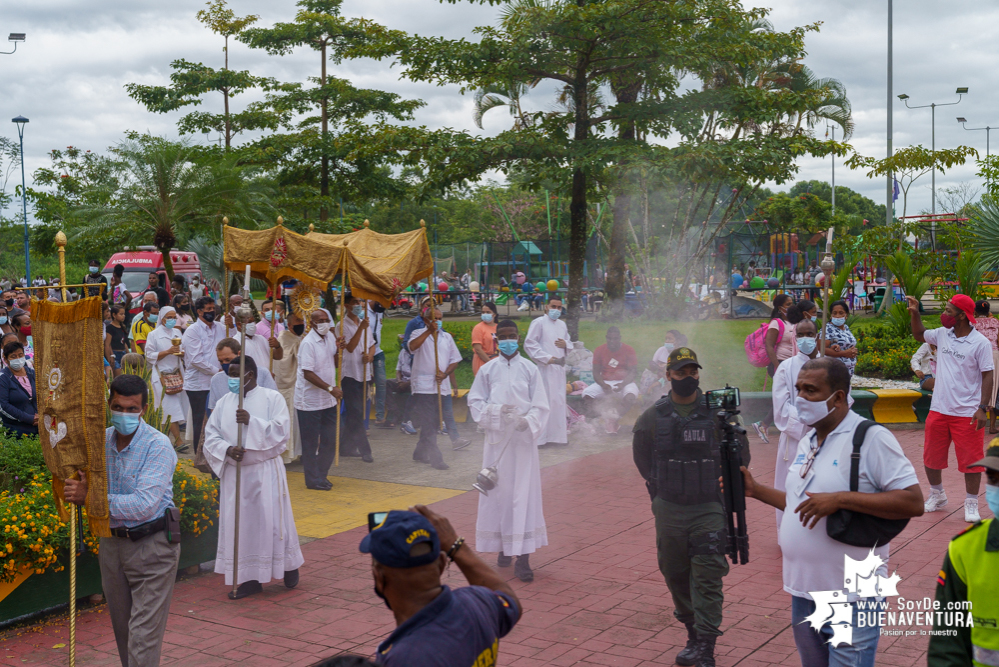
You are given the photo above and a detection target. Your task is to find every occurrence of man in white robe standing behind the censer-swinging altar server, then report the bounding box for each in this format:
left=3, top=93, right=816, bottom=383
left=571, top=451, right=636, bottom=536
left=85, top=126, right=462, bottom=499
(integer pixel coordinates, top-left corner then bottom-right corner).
left=524, top=296, right=571, bottom=447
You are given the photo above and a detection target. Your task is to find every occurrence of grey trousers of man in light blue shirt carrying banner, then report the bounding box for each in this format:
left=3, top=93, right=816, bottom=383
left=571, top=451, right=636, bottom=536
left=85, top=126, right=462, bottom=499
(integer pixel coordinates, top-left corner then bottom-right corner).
left=99, top=530, right=180, bottom=667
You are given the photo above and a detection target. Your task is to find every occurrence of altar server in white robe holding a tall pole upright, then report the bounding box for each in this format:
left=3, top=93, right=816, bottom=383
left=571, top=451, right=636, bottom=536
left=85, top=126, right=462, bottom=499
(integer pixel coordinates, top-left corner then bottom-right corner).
left=205, top=357, right=305, bottom=600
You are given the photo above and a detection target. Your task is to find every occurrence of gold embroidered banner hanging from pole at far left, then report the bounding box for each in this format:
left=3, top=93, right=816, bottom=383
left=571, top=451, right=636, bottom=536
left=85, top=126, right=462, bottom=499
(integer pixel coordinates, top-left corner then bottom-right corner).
left=31, top=296, right=111, bottom=537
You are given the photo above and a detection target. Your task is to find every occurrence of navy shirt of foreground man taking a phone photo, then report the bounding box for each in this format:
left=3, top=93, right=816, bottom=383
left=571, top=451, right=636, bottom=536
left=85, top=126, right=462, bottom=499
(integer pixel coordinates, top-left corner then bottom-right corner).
left=377, top=586, right=520, bottom=667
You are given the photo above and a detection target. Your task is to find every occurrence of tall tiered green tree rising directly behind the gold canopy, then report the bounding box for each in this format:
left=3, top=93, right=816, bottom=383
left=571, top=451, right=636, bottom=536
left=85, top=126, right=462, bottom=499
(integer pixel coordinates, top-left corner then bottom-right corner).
left=238, top=0, right=423, bottom=221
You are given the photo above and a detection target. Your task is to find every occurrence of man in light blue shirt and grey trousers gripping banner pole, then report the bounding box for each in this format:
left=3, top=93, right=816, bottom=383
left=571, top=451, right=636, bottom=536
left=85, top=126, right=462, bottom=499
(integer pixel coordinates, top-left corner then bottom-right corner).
left=65, top=375, right=180, bottom=667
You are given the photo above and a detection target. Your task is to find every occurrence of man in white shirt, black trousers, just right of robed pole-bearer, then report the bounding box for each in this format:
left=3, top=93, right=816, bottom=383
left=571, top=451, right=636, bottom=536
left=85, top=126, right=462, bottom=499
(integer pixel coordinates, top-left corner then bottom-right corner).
left=295, top=309, right=343, bottom=491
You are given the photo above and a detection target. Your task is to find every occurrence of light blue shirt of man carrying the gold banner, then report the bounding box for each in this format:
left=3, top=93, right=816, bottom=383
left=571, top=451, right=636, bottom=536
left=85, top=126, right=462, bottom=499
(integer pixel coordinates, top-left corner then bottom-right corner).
left=104, top=421, right=177, bottom=528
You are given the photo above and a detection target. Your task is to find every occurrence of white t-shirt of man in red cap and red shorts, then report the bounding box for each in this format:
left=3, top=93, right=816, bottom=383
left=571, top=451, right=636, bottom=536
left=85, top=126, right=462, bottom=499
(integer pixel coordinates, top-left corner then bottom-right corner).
left=923, top=327, right=993, bottom=417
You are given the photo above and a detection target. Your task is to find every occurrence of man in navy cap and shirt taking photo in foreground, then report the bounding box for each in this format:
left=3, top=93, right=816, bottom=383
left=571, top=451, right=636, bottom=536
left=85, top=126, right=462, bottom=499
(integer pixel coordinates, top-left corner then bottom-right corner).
left=360, top=505, right=521, bottom=667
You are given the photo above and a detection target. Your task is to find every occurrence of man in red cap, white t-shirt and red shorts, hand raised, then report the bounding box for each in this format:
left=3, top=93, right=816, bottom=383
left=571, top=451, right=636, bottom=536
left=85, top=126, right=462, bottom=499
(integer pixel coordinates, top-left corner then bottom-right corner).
left=906, top=294, right=995, bottom=523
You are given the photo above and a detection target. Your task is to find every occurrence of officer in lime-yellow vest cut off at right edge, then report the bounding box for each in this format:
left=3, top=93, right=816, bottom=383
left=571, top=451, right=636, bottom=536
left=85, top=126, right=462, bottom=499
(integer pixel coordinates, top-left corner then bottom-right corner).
left=927, top=440, right=999, bottom=667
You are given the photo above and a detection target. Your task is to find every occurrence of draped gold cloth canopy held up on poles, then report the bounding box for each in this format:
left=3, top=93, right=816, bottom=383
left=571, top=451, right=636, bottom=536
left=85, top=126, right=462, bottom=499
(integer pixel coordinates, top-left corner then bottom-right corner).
left=224, top=225, right=434, bottom=307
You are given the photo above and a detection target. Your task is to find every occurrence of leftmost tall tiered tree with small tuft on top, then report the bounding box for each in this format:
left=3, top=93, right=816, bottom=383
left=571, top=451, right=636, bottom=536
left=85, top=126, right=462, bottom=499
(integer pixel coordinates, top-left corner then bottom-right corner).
left=125, top=0, right=282, bottom=150
